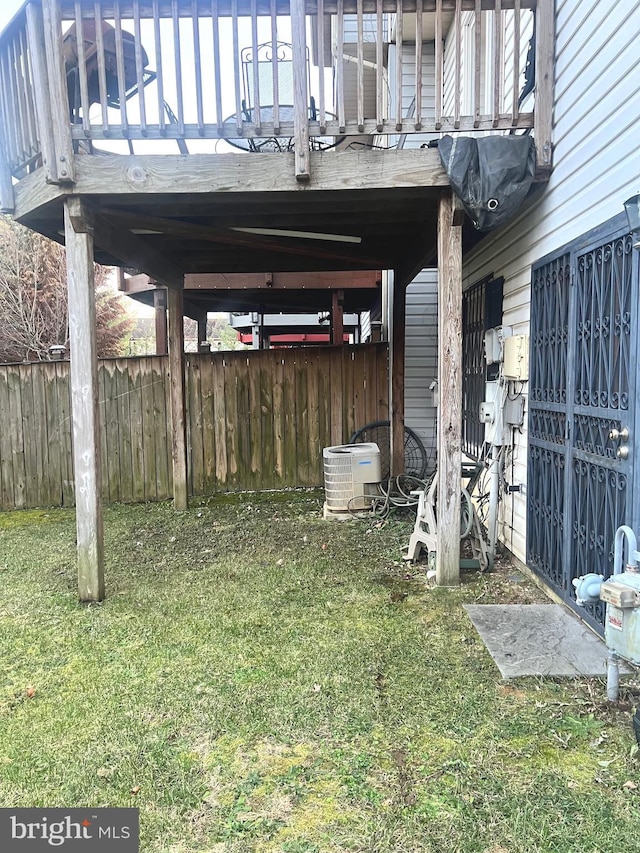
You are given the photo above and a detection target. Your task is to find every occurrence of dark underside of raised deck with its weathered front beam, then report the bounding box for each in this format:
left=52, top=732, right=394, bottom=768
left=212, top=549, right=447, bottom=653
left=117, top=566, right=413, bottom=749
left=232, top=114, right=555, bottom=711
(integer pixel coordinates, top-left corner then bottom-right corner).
left=15, top=150, right=448, bottom=288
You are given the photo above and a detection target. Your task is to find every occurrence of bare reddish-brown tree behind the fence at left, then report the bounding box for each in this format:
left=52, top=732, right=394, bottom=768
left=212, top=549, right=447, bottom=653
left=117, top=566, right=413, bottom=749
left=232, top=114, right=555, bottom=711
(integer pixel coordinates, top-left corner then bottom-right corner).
left=0, top=217, right=134, bottom=362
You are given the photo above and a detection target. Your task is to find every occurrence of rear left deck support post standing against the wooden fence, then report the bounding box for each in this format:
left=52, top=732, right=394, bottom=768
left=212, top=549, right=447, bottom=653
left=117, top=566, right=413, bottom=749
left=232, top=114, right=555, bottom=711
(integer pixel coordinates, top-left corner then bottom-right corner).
left=167, top=288, right=187, bottom=510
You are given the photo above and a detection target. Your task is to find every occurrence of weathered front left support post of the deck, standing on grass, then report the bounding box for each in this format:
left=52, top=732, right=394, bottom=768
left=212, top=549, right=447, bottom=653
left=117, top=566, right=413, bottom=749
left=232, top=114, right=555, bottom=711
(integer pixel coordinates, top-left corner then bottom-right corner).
left=64, top=196, right=104, bottom=601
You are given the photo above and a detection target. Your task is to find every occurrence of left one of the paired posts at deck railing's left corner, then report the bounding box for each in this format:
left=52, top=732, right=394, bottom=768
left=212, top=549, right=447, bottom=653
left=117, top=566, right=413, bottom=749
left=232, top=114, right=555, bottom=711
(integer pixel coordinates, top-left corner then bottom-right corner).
left=25, top=3, right=58, bottom=184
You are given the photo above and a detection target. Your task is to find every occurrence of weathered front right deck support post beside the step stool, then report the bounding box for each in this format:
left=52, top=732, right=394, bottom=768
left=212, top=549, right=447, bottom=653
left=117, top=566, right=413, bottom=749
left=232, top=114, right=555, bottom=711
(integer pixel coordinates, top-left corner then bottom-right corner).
left=436, top=192, right=462, bottom=586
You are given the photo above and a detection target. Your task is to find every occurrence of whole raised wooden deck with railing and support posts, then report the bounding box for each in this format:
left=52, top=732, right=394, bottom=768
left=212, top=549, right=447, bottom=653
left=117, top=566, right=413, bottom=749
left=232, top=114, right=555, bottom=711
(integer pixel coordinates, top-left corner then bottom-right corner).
left=0, top=0, right=555, bottom=600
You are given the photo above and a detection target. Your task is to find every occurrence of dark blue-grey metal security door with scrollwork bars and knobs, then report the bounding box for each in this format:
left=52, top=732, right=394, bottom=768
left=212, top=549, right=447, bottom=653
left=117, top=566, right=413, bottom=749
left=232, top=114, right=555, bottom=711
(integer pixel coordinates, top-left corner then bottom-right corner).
left=527, top=223, right=640, bottom=629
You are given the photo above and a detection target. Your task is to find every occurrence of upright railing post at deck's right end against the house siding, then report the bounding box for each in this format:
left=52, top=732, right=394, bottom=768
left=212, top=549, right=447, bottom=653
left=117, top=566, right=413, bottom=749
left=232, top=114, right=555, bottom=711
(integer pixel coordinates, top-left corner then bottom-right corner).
left=533, top=0, right=555, bottom=171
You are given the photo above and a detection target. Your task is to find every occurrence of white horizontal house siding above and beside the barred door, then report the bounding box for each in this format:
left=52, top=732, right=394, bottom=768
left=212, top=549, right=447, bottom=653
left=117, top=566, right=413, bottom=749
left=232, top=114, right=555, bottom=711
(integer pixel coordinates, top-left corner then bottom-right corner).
left=463, top=0, right=640, bottom=561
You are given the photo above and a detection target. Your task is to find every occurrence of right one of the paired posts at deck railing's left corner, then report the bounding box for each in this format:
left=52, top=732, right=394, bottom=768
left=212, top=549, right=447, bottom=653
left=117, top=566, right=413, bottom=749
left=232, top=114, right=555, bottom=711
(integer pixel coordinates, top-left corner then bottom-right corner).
left=42, top=0, right=75, bottom=183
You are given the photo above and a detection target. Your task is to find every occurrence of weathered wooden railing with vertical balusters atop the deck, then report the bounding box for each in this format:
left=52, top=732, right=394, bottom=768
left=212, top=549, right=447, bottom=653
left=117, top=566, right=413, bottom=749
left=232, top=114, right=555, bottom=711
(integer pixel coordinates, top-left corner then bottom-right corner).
left=0, top=0, right=553, bottom=195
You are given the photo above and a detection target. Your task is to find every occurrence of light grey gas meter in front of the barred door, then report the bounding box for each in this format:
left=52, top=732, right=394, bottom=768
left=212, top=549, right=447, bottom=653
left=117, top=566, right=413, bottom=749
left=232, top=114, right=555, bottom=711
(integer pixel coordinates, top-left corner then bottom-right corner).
left=600, top=572, right=640, bottom=666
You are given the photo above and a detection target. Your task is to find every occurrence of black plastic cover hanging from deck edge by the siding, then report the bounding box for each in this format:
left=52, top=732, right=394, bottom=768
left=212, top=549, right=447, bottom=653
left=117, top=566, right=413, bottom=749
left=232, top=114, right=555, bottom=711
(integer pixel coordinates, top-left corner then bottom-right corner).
left=438, top=135, right=536, bottom=231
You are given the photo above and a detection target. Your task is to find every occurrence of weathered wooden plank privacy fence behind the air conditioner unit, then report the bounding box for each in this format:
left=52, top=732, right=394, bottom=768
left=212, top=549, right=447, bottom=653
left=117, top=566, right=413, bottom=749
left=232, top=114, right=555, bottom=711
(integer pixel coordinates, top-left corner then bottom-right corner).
left=0, top=344, right=388, bottom=510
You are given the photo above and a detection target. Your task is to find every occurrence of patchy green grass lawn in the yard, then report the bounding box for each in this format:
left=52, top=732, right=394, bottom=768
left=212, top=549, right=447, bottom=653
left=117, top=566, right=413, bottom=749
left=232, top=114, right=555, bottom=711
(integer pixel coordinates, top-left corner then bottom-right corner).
left=0, top=491, right=640, bottom=853
